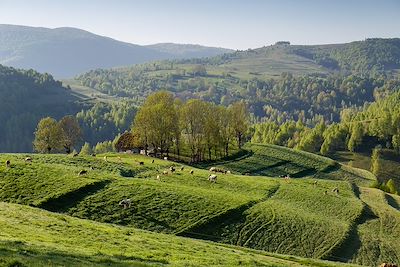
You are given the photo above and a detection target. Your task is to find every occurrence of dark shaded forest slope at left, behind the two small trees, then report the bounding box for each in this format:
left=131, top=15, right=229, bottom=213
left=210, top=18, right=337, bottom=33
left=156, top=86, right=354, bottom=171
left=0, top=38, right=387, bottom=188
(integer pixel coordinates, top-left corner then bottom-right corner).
left=0, top=65, right=136, bottom=152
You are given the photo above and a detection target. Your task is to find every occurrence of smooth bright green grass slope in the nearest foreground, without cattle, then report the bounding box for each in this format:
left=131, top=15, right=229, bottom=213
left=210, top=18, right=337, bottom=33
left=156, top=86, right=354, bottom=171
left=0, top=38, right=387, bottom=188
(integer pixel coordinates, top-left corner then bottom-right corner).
left=0, top=202, right=360, bottom=266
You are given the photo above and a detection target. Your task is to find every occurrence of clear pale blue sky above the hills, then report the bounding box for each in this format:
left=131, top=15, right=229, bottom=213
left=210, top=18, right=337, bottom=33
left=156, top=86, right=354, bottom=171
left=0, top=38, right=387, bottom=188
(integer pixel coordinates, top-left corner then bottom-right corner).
left=0, top=0, right=400, bottom=49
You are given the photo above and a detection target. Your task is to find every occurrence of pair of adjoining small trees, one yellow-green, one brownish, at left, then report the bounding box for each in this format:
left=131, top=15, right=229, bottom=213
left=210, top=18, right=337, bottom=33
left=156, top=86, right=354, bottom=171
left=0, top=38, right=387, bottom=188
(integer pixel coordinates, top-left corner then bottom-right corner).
left=33, top=116, right=82, bottom=154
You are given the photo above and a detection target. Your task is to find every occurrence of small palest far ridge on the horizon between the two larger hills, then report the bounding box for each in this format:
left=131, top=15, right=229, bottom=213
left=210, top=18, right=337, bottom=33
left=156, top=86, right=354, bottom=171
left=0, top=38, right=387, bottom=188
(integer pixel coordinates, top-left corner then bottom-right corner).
left=146, top=43, right=233, bottom=58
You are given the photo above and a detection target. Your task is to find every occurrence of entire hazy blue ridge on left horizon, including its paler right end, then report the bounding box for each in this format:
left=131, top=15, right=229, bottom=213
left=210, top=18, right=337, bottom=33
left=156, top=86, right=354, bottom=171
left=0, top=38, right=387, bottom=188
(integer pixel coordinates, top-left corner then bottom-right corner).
left=0, top=25, right=233, bottom=78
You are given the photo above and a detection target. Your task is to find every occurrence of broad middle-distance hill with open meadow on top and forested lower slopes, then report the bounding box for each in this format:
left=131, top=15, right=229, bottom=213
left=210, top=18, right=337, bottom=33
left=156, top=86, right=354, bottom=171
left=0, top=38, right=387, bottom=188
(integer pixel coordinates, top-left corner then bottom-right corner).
left=74, top=39, right=400, bottom=124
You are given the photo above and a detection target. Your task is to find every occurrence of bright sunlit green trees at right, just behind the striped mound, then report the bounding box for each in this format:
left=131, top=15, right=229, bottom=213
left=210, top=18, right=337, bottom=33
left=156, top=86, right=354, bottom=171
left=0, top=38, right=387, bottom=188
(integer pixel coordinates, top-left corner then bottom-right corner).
left=252, top=87, right=400, bottom=155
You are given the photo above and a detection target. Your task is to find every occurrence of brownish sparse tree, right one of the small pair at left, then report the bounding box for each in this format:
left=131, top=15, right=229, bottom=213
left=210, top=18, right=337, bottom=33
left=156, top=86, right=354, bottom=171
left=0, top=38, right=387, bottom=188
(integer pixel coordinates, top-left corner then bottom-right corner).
left=59, top=115, right=82, bottom=154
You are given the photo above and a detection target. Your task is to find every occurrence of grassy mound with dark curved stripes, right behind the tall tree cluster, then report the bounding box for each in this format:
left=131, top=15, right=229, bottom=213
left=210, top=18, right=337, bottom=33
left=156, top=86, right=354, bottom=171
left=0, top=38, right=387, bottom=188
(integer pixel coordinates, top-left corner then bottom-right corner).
left=207, top=144, right=376, bottom=185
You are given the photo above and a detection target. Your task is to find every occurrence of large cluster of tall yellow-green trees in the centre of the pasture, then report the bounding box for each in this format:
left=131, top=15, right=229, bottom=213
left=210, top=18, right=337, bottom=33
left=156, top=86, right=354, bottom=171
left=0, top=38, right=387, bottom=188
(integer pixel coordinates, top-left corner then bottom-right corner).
left=132, top=91, right=248, bottom=162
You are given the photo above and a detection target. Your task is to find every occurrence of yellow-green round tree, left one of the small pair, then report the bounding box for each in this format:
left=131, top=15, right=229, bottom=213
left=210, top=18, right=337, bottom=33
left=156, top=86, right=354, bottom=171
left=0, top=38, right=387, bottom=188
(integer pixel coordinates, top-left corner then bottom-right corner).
left=33, top=117, right=63, bottom=153
